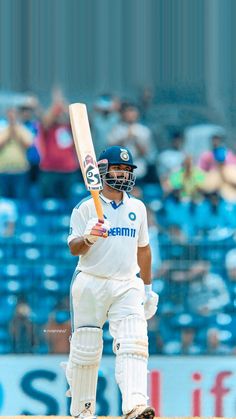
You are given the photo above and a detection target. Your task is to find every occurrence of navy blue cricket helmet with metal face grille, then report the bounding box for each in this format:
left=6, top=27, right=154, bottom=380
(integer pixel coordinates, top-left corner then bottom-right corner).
left=98, top=146, right=137, bottom=192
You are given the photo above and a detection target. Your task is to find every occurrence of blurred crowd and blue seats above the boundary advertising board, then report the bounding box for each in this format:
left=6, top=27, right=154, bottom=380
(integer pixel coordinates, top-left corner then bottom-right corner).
left=0, top=91, right=236, bottom=355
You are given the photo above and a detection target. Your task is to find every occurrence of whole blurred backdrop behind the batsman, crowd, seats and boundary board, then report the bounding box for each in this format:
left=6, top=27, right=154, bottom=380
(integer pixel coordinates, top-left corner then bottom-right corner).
left=0, top=0, right=236, bottom=417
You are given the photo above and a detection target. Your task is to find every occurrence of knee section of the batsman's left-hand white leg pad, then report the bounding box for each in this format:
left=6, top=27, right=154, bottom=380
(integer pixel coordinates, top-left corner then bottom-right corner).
left=70, top=327, right=103, bottom=366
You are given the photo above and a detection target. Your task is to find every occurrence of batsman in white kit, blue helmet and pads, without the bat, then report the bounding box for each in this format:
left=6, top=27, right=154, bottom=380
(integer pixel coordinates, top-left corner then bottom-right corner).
left=66, top=146, right=158, bottom=419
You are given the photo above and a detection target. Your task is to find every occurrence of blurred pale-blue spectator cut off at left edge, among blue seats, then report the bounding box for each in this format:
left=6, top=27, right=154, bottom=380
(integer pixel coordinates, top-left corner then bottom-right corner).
left=0, top=198, right=17, bottom=237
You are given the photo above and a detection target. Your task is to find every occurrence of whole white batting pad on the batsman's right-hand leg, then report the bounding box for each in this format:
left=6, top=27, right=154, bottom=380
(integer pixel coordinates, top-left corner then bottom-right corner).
left=113, top=316, right=148, bottom=414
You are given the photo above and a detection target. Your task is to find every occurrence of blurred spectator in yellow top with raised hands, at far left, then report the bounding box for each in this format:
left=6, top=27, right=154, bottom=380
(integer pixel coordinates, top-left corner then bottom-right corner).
left=0, top=109, right=33, bottom=199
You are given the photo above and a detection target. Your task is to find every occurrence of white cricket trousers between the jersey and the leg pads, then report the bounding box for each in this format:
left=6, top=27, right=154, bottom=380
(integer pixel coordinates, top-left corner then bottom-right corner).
left=71, top=272, right=145, bottom=338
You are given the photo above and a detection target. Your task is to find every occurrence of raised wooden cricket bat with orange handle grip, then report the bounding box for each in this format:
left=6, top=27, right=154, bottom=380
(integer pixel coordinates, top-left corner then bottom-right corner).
left=69, top=103, right=104, bottom=222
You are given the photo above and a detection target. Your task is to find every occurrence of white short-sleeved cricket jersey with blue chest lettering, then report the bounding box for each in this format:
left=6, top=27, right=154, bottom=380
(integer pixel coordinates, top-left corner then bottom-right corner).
left=68, top=192, right=149, bottom=280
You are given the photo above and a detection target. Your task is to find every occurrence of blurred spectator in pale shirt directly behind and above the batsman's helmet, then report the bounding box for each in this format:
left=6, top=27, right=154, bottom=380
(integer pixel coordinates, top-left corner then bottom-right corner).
left=108, top=103, right=155, bottom=184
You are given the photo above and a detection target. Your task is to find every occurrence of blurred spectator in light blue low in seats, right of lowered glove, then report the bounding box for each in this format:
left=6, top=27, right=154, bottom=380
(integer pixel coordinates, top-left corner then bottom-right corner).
left=187, top=261, right=230, bottom=317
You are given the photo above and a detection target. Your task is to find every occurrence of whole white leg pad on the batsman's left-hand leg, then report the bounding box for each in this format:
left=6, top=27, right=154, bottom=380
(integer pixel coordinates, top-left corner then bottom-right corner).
left=66, top=327, right=103, bottom=416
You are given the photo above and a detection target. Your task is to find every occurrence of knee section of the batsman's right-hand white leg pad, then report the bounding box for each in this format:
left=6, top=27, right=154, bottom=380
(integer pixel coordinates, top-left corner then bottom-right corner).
left=113, top=316, right=148, bottom=358
